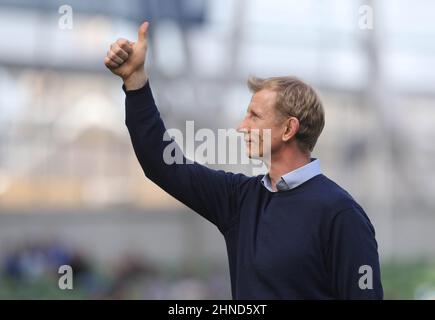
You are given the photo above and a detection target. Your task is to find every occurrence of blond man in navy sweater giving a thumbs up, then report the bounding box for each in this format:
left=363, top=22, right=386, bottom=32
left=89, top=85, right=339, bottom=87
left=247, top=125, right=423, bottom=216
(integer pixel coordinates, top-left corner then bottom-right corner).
left=105, top=22, right=383, bottom=299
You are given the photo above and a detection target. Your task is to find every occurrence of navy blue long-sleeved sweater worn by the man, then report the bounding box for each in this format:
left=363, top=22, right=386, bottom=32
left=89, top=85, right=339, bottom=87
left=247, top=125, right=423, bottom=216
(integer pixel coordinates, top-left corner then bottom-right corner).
left=123, top=83, right=383, bottom=299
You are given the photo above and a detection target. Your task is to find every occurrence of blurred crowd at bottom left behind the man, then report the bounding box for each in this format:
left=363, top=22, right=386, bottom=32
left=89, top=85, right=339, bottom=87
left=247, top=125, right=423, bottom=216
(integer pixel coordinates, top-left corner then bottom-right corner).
left=0, top=241, right=230, bottom=299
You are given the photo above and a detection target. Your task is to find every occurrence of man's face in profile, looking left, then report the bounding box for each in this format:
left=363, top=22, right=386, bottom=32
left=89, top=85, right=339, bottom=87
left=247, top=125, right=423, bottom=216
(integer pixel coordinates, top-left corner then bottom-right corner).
left=237, top=89, right=284, bottom=158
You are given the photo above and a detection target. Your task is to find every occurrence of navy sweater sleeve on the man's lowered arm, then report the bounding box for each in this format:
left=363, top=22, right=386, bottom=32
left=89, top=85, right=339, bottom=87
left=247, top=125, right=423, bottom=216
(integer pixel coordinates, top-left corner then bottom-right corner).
left=329, top=207, right=383, bottom=300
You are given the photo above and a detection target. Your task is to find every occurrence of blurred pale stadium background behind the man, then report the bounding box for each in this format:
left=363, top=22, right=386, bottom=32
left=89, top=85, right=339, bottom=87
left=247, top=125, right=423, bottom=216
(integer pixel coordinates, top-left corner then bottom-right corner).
left=0, top=0, right=435, bottom=299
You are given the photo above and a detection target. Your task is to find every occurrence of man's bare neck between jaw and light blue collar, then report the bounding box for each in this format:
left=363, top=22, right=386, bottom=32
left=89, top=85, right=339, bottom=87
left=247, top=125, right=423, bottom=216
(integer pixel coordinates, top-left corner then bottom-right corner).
left=266, top=146, right=311, bottom=191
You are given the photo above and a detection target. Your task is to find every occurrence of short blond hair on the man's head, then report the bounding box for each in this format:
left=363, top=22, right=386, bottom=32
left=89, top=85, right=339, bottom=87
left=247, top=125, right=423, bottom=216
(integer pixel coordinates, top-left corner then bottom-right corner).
left=248, top=76, right=325, bottom=152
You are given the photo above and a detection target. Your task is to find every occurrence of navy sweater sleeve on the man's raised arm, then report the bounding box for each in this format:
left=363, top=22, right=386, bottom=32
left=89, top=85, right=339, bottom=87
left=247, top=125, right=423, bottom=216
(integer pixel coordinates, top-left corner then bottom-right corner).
left=123, top=82, right=248, bottom=232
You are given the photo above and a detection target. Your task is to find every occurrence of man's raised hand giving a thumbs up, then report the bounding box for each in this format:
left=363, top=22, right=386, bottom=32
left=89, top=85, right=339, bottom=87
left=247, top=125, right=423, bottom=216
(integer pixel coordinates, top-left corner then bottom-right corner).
left=104, top=22, right=149, bottom=90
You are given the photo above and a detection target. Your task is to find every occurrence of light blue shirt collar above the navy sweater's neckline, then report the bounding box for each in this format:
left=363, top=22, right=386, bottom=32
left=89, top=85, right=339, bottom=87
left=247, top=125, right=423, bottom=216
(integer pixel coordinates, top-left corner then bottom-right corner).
left=261, top=158, right=322, bottom=192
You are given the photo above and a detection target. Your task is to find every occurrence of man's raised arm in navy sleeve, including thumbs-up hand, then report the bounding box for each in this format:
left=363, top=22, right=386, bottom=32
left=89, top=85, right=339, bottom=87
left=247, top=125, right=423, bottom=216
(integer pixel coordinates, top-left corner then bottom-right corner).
left=105, top=22, right=250, bottom=232
